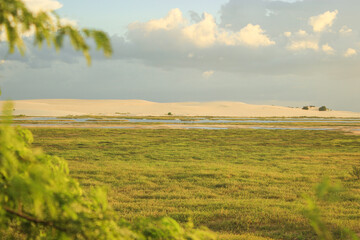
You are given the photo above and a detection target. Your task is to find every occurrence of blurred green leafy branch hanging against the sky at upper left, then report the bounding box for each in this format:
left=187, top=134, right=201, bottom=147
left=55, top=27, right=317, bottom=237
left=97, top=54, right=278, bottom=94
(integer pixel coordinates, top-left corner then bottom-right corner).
left=0, top=0, right=112, bottom=64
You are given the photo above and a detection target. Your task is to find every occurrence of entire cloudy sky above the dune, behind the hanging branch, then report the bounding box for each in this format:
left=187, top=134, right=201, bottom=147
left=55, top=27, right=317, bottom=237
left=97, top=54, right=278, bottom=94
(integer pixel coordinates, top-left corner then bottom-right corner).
left=0, top=0, right=360, bottom=112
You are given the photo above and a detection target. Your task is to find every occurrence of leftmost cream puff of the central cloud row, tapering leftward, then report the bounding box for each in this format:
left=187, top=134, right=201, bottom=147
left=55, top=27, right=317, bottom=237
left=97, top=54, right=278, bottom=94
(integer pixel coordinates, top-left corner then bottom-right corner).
left=129, top=8, right=187, bottom=32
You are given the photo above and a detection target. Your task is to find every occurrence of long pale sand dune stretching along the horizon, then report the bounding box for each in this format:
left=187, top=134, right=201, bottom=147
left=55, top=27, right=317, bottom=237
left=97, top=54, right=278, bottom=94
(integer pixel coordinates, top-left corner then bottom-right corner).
left=0, top=99, right=360, bottom=118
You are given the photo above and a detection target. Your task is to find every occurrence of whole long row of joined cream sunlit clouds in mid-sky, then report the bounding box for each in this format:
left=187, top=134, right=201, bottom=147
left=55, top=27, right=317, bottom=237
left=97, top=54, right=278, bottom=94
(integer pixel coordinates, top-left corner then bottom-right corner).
left=129, top=9, right=275, bottom=48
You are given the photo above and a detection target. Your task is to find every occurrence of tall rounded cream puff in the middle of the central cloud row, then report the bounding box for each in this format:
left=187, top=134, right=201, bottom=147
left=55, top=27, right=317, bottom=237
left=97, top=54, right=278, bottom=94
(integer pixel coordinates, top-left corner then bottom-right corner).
left=182, top=13, right=217, bottom=48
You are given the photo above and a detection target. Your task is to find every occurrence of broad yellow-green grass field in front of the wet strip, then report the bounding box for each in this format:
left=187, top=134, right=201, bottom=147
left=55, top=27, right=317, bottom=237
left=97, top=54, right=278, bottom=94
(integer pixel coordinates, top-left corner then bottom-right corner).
left=31, top=128, right=360, bottom=239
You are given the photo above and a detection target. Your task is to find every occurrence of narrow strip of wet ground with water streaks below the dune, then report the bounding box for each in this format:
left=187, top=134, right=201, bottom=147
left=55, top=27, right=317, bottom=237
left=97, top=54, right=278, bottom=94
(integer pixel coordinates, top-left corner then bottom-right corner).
left=8, top=116, right=360, bottom=135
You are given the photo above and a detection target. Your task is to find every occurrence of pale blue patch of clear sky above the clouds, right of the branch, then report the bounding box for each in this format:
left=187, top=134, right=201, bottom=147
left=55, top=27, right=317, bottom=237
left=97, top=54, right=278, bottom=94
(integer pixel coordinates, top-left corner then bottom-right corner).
left=58, top=0, right=227, bottom=34
